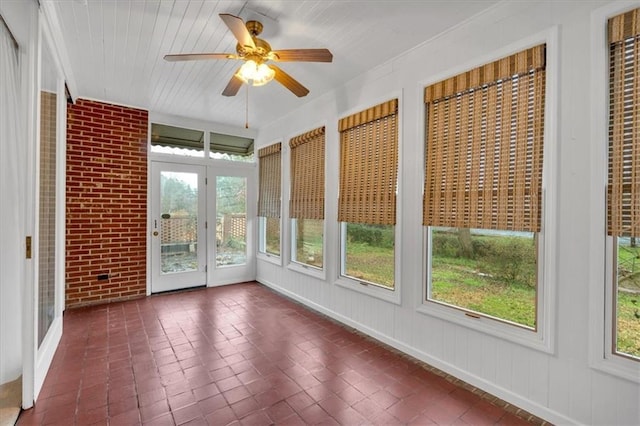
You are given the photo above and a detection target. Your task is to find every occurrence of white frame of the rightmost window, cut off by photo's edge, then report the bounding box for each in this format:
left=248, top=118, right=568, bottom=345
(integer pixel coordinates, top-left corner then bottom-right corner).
left=589, top=2, right=640, bottom=383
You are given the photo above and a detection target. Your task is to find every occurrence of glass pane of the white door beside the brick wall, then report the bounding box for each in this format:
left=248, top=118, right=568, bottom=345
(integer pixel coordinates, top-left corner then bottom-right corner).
left=160, top=171, right=198, bottom=274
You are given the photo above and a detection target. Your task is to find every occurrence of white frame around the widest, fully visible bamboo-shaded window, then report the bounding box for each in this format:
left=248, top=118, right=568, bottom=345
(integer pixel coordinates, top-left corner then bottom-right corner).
left=416, top=30, right=559, bottom=353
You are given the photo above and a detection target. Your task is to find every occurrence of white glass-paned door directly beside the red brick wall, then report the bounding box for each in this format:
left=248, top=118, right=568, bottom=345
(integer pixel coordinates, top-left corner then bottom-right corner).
left=150, top=162, right=207, bottom=293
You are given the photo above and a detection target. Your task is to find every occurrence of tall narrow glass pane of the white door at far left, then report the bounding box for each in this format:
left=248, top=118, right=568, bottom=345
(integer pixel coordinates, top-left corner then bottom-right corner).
left=38, top=46, right=57, bottom=347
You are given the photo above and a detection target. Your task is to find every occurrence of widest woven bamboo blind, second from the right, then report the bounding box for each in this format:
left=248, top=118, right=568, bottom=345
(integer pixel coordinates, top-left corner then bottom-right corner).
left=423, top=45, right=545, bottom=232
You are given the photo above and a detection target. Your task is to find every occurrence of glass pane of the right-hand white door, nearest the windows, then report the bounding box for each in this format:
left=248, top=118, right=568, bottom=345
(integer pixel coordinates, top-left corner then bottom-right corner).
left=216, top=176, right=247, bottom=266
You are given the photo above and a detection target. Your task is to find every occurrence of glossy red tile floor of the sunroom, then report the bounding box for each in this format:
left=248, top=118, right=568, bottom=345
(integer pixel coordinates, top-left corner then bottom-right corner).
left=18, top=283, right=541, bottom=426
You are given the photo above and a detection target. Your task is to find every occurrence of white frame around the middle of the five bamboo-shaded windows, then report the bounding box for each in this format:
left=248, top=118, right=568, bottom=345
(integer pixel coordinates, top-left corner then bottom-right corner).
left=332, top=91, right=404, bottom=305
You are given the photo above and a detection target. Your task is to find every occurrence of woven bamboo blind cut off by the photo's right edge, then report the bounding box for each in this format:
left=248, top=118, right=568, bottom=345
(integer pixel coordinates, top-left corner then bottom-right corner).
left=607, top=9, right=640, bottom=237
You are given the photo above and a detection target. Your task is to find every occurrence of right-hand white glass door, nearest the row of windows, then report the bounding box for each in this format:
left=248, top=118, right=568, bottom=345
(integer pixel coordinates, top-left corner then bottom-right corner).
left=207, top=166, right=255, bottom=286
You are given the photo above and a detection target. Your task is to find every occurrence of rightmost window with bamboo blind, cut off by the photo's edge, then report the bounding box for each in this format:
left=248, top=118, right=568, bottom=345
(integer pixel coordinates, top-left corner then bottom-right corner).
left=607, top=9, right=640, bottom=361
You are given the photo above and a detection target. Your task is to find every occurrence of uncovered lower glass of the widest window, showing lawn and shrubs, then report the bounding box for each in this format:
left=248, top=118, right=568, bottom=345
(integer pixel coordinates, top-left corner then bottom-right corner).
left=429, top=227, right=538, bottom=329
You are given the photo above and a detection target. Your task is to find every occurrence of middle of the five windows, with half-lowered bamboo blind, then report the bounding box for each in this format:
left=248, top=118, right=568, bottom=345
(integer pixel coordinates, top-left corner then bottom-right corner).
left=338, top=99, right=398, bottom=290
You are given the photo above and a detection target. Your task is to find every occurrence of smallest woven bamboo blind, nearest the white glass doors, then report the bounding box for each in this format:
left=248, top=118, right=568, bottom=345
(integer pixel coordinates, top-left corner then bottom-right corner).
left=258, top=143, right=281, bottom=217
